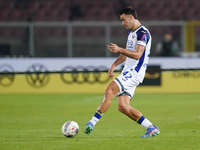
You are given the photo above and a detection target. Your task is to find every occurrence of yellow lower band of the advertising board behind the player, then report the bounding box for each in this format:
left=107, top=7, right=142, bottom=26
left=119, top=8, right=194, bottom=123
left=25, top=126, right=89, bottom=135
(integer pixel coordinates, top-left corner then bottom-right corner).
left=0, top=65, right=200, bottom=94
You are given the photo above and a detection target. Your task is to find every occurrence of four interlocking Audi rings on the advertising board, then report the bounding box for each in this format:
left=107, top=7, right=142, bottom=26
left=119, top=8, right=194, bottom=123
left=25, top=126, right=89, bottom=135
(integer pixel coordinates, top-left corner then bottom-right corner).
left=61, top=66, right=110, bottom=84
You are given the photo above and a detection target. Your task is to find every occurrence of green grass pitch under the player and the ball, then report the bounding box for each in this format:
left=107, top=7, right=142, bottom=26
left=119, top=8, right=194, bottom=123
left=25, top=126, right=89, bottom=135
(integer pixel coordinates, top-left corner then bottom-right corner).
left=0, top=93, right=200, bottom=150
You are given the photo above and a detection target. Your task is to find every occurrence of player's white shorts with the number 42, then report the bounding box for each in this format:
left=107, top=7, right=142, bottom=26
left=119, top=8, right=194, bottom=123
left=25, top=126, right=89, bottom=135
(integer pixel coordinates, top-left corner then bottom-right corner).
left=114, top=69, right=140, bottom=98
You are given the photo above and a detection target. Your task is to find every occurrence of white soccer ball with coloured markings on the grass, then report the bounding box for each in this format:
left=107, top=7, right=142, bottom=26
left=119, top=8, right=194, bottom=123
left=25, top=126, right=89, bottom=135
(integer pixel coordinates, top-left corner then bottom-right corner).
left=61, top=121, right=79, bottom=137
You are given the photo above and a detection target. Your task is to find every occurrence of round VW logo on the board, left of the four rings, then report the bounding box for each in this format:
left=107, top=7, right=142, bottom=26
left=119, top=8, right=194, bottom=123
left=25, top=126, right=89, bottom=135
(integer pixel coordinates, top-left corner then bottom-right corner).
left=26, top=63, right=50, bottom=88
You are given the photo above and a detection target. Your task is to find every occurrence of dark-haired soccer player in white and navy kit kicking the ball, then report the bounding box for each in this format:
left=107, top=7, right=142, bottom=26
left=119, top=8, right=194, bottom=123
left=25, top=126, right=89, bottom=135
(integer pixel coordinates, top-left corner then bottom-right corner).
left=85, top=6, right=160, bottom=138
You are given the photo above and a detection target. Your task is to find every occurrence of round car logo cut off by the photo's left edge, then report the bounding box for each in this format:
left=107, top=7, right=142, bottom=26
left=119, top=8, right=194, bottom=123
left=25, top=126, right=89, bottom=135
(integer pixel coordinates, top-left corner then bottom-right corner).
left=0, top=64, right=15, bottom=87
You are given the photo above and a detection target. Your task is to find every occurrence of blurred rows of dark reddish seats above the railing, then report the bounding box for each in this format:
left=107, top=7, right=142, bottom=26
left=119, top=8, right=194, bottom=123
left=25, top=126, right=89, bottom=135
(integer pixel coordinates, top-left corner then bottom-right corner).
left=0, top=0, right=200, bottom=21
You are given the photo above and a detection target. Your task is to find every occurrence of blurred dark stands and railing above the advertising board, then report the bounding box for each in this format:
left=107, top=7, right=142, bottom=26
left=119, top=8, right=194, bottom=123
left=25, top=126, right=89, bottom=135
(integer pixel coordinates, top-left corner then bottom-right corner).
left=0, top=0, right=200, bottom=57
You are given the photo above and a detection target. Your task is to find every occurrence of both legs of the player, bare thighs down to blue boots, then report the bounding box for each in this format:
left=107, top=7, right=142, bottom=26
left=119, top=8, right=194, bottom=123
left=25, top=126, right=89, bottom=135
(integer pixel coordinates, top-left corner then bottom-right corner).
left=85, top=81, right=160, bottom=138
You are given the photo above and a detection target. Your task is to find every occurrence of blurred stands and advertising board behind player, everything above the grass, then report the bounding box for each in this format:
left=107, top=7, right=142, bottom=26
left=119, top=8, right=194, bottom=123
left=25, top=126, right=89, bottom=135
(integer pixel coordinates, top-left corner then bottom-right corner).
left=0, top=0, right=200, bottom=93
